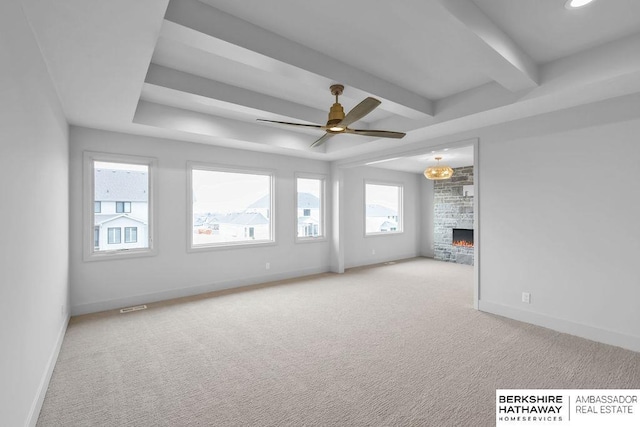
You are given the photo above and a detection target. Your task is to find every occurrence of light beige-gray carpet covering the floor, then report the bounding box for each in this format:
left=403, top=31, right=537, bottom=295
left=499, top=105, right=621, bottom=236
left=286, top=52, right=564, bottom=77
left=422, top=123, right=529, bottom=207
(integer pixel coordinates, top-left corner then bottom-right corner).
left=38, top=258, right=640, bottom=426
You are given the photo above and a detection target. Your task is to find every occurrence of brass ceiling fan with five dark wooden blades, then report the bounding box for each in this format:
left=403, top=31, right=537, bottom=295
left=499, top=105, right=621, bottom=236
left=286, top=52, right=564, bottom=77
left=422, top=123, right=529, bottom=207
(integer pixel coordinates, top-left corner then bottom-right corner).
left=258, top=84, right=406, bottom=147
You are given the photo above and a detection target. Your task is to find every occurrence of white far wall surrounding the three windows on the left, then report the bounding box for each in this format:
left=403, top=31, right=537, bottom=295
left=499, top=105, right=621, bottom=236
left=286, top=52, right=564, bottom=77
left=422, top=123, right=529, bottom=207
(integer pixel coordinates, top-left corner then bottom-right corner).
left=70, top=127, right=331, bottom=314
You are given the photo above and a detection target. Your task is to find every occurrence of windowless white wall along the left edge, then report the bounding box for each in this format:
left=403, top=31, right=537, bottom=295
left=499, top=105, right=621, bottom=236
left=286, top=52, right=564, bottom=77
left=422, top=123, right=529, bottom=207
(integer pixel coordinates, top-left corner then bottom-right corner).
left=0, top=0, right=69, bottom=426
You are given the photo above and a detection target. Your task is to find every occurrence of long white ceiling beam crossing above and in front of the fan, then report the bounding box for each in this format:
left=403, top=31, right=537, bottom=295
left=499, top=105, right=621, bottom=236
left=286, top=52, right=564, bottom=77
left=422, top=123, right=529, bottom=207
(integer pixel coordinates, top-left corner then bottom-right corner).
left=163, top=0, right=433, bottom=119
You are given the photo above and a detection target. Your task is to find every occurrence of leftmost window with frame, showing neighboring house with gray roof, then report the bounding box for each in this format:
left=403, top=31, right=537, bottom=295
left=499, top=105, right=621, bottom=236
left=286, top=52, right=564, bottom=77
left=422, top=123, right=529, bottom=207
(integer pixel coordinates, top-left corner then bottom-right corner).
left=83, top=152, right=156, bottom=261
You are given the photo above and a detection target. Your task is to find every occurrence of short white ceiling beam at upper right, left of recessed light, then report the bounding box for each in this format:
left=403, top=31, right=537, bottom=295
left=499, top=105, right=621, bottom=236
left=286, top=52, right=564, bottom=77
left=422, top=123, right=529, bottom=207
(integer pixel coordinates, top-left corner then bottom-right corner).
left=438, top=0, right=539, bottom=92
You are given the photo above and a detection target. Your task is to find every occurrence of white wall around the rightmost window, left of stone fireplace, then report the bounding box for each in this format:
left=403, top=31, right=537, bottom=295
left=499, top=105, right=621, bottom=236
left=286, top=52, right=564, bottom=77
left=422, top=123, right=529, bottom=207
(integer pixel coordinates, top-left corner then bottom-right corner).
left=341, top=166, right=424, bottom=268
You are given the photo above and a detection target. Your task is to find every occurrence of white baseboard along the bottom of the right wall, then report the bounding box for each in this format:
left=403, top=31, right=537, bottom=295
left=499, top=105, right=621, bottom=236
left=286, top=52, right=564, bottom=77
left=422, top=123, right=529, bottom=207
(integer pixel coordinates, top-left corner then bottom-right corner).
left=478, top=300, right=640, bottom=352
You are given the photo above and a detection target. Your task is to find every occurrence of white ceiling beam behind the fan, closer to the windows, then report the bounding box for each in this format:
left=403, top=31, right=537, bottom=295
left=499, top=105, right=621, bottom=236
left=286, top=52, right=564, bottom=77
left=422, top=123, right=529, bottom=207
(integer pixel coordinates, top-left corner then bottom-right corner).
left=145, top=64, right=327, bottom=123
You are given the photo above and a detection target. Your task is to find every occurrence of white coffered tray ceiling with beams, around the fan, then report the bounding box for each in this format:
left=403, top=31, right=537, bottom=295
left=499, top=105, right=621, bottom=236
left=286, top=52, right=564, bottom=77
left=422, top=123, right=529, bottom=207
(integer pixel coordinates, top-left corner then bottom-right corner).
left=24, top=0, right=640, bottom=166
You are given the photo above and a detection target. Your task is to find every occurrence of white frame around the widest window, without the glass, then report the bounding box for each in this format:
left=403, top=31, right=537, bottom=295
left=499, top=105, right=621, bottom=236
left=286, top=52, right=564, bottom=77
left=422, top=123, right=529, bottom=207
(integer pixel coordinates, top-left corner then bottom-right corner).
left=187, top=161, right=277, bottom=253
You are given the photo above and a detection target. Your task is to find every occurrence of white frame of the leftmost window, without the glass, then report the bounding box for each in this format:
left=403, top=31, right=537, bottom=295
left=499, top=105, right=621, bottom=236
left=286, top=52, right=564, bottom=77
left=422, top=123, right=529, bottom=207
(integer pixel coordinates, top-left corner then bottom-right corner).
left=82, top=151, right=158, bottom=262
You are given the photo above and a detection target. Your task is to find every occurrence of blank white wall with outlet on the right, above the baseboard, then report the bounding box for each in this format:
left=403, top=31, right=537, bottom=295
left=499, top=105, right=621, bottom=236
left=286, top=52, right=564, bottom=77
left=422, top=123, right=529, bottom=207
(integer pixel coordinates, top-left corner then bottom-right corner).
left=478, top=117, right=640, bottom=351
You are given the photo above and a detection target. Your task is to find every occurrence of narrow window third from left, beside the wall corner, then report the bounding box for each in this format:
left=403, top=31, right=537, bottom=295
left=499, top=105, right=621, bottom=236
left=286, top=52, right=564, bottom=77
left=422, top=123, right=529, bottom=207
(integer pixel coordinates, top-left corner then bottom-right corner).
left=296, top=174, right=325, bottom=241
